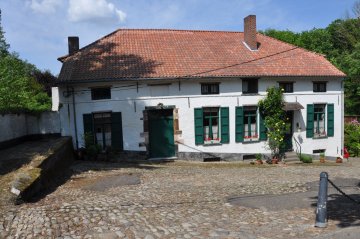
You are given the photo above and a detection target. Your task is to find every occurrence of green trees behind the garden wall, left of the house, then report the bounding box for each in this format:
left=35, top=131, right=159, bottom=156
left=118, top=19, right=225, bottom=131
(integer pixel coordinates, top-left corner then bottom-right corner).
left=0, top=10, right=55, bottom=113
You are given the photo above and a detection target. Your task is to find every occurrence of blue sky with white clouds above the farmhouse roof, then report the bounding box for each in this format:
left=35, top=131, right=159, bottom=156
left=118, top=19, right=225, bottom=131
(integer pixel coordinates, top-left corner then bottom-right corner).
left=0, top=0, right=355, bottom=75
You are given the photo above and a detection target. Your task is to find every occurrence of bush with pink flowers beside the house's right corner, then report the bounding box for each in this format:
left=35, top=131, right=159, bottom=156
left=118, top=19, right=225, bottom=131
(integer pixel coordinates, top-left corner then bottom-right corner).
left=344, top=121, right=360, bottom=157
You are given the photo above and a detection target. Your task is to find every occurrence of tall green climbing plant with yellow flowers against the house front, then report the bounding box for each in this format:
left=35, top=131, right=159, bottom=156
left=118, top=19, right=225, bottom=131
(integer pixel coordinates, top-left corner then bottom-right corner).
left=258, top=87, right=287, bottom=159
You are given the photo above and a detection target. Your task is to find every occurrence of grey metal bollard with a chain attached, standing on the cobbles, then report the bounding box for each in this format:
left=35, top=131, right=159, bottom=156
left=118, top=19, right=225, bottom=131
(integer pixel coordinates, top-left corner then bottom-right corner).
left=315, top=172, right=328, bottom=227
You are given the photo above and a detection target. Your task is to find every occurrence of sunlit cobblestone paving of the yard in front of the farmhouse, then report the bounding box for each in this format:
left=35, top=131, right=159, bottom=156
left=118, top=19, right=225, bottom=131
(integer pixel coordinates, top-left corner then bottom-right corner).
left=0, top=161, right=360, bottom=239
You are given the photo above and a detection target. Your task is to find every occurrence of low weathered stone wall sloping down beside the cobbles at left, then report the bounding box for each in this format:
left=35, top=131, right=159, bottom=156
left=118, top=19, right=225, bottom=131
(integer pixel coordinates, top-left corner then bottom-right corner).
left=11, top=137, right=74, bottom=203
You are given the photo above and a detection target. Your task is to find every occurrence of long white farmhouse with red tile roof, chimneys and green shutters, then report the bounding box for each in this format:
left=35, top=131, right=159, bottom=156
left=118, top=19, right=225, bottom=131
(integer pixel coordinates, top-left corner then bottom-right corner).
left=59, top=15, right=345, bottom=160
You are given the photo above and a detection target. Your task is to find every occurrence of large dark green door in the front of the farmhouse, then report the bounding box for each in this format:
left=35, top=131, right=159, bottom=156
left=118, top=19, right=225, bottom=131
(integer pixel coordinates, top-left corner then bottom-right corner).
left=148, top=109, right=175, bottom=158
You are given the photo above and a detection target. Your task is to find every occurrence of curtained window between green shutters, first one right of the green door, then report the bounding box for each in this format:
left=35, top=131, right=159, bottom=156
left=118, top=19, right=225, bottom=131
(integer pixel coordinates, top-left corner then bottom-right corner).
left=203, top=107, right=220, bottom=144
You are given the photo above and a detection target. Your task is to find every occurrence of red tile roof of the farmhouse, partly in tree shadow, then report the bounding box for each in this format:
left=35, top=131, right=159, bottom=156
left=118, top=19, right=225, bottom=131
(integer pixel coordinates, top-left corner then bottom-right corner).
left=59, top=29, right=345, bottom=82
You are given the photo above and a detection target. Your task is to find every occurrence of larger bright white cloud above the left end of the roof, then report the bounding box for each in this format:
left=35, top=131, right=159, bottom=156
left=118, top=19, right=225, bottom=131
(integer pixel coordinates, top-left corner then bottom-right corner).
left=68, top=0, right=126, bottom=22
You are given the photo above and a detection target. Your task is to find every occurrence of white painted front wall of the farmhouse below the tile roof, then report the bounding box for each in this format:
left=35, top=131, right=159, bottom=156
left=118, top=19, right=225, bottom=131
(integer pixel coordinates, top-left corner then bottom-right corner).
left=59, top=77, right=343, bottom=156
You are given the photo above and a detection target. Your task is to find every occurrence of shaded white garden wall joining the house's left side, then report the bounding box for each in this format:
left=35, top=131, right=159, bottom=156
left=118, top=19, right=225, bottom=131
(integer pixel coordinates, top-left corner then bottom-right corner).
left=0, top=112, right=60, bottom=149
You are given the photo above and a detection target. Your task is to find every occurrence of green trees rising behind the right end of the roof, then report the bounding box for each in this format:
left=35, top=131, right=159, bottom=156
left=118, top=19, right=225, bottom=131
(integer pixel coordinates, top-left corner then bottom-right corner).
left=262, top=16, right=360, bottom=115
